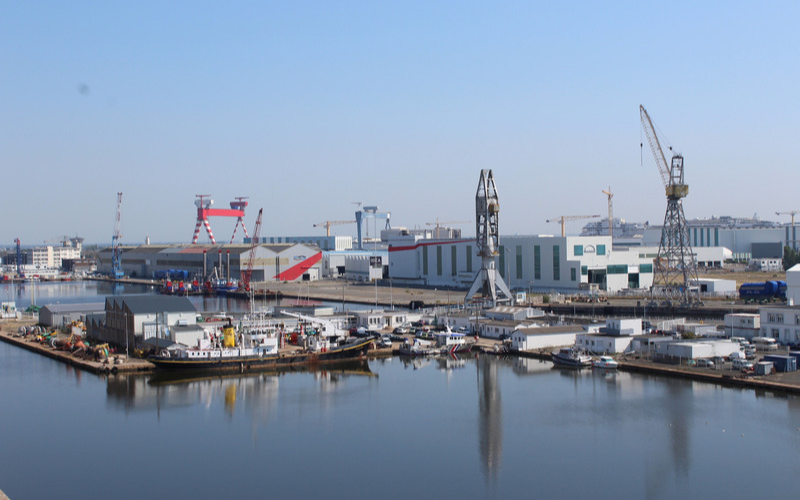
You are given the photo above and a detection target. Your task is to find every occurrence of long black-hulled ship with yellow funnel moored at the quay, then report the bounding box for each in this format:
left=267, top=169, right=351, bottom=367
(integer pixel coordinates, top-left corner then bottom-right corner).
left=147, top=318, right=374, bottom=371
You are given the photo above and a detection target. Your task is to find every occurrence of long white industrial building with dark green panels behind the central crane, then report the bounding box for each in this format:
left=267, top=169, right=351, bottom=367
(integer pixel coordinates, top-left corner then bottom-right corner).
left=389, top=235, right=653, bottom=292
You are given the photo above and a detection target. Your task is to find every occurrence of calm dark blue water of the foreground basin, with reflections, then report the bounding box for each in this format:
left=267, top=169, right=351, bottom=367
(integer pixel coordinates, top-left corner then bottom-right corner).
left=0, top=343, right=800, bottom=500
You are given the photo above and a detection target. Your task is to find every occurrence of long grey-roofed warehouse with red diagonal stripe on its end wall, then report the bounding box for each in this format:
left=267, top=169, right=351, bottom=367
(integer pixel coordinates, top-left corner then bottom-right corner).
left=98, top=244, right=322, bottom=282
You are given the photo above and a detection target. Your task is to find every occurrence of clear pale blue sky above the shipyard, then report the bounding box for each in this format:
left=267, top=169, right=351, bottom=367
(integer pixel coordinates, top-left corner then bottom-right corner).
left=0, top=0, right=800, bottom=245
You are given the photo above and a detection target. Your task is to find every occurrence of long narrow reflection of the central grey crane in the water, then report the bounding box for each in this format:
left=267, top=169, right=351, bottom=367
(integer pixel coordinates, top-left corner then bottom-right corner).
left=477, top=355, right=503, bottom=484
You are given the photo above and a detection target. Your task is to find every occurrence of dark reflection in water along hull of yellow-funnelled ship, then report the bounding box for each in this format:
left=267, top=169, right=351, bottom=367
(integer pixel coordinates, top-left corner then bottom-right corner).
left=147, top=359, right=378, bottom=387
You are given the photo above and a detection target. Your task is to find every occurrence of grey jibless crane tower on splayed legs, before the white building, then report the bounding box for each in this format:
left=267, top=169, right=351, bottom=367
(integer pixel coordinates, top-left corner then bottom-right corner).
left=464, top=170, right=511, bottom=307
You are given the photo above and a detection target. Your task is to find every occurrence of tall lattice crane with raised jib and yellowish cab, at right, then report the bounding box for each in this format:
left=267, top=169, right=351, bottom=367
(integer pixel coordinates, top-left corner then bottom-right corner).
left=639, top=105, right=699, bottom=306
